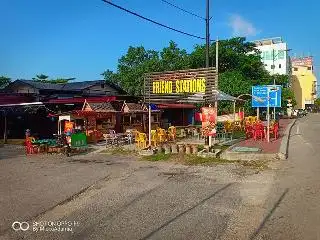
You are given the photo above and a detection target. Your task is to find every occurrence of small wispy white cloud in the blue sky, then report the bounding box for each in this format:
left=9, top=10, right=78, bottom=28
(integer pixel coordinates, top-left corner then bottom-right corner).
left=229, top=14, right=259, bottom=37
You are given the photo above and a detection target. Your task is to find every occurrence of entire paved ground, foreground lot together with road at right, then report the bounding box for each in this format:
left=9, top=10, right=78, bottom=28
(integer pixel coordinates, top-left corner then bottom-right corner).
left=0, top=115, right=320, bottom=240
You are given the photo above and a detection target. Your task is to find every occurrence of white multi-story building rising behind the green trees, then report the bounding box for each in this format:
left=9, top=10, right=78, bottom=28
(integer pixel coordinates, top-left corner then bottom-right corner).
left=253, top=37, right=291, bottom=75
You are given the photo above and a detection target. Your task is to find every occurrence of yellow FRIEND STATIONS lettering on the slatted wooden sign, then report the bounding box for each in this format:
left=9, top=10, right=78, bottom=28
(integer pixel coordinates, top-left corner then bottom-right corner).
left=152, top=78, right=206, bottom=94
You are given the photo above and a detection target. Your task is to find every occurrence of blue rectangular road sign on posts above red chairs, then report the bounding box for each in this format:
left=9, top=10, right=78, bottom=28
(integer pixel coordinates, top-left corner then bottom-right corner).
left=252, top=85, right=282, bottom=107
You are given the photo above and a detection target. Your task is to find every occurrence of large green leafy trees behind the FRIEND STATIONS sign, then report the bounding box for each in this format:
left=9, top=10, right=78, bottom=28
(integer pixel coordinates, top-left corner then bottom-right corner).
left=102, top=38, right=294, bottom=115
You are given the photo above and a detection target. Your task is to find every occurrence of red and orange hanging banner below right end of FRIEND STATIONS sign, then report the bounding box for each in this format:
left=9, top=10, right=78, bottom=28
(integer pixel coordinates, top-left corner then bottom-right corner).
left=201, top=107, right=217, bottom=136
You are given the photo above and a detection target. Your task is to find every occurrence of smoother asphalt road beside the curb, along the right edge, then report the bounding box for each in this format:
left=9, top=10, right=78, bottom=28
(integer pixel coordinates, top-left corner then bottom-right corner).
left=255, top=114, right=320, bottom=240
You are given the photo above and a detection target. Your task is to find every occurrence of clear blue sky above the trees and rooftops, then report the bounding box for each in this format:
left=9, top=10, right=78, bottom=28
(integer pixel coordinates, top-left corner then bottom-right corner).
left=0, top=0, right=320, bottom=84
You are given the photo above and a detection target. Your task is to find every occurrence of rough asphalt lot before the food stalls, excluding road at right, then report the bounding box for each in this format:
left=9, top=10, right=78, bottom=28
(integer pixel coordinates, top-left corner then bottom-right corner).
left=0, top=144, right=273, bottom=240
